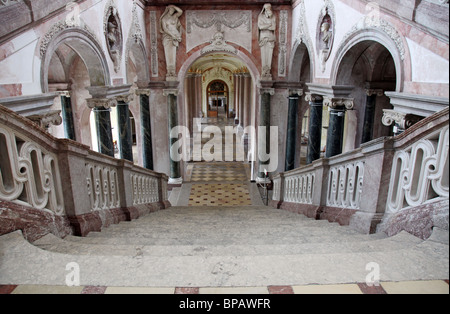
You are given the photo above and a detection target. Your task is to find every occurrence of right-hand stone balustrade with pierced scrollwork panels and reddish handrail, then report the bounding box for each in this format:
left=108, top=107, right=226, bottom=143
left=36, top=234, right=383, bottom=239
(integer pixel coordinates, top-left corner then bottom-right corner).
left=272, top=107, right=449, bottom=232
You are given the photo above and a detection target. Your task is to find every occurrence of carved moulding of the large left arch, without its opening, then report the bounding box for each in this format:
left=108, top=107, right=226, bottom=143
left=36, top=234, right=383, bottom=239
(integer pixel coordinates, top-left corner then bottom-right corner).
left=41, top=24, right=110, bottom=93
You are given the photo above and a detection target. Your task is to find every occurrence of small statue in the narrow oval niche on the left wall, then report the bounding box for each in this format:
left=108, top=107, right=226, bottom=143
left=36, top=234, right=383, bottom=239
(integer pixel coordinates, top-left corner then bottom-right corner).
left=106, top=7, right=122, bottom=73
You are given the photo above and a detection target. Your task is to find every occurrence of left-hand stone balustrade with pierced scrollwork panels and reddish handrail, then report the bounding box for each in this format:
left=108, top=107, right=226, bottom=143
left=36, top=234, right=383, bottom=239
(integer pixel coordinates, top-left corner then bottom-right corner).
left=0, top=105, right=170, bottom=234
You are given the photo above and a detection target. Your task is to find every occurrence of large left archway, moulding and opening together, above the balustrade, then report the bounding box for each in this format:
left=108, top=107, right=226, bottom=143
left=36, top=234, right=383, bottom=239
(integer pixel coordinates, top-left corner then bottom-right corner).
left=41, top=27, right=110, bottom=147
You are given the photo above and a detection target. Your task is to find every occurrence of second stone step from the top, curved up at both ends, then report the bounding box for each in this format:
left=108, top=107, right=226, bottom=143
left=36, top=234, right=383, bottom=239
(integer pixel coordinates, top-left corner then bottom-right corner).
left=34, top=232, right=423, bottom=257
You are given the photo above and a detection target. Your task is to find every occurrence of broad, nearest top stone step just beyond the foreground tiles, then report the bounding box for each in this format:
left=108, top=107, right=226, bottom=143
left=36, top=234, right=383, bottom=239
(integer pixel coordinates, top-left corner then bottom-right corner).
left=0, top=232, right=448, bottom=287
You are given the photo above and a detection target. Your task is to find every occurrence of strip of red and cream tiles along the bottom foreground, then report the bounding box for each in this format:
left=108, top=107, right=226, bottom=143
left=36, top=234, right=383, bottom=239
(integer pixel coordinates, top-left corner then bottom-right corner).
left=0, top=280, right=449, bottom=295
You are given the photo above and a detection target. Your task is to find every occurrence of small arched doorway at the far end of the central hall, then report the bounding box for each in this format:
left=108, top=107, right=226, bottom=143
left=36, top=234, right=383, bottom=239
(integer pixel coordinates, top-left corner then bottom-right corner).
left=206, top=80, right=230, bottom=119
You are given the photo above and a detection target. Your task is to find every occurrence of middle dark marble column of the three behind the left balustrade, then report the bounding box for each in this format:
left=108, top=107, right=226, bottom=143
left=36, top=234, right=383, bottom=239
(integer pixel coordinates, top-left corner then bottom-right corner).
left=117, top=94, right=133, bottom=162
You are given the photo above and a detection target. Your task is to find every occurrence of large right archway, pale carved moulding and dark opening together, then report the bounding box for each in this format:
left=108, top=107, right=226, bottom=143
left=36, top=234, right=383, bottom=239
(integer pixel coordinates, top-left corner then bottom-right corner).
left=331, top=22, right=406, bottom=152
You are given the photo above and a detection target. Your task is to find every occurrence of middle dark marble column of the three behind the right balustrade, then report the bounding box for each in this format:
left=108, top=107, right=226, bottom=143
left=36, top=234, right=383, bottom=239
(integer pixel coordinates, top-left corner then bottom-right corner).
left=305, top=93, right=323, bottom=164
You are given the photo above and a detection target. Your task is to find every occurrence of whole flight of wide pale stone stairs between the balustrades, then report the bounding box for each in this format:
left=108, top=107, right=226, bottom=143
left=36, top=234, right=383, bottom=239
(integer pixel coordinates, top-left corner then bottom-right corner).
left=0, top=206, right=449, bottom=287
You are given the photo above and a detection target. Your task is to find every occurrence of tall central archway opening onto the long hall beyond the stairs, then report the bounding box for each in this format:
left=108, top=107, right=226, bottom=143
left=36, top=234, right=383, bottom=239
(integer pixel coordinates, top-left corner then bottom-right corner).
left=178, top=52, right=259, bottom=169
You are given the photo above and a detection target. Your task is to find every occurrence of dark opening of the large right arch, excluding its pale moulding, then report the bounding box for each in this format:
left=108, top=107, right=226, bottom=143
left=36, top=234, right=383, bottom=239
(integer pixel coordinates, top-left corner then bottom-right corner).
left=335, top=40, right=401, bottom=152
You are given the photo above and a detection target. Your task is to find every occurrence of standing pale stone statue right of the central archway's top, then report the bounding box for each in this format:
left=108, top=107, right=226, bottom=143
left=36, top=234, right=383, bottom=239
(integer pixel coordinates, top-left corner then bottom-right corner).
left=258, top=3, right=277, bottom=80
